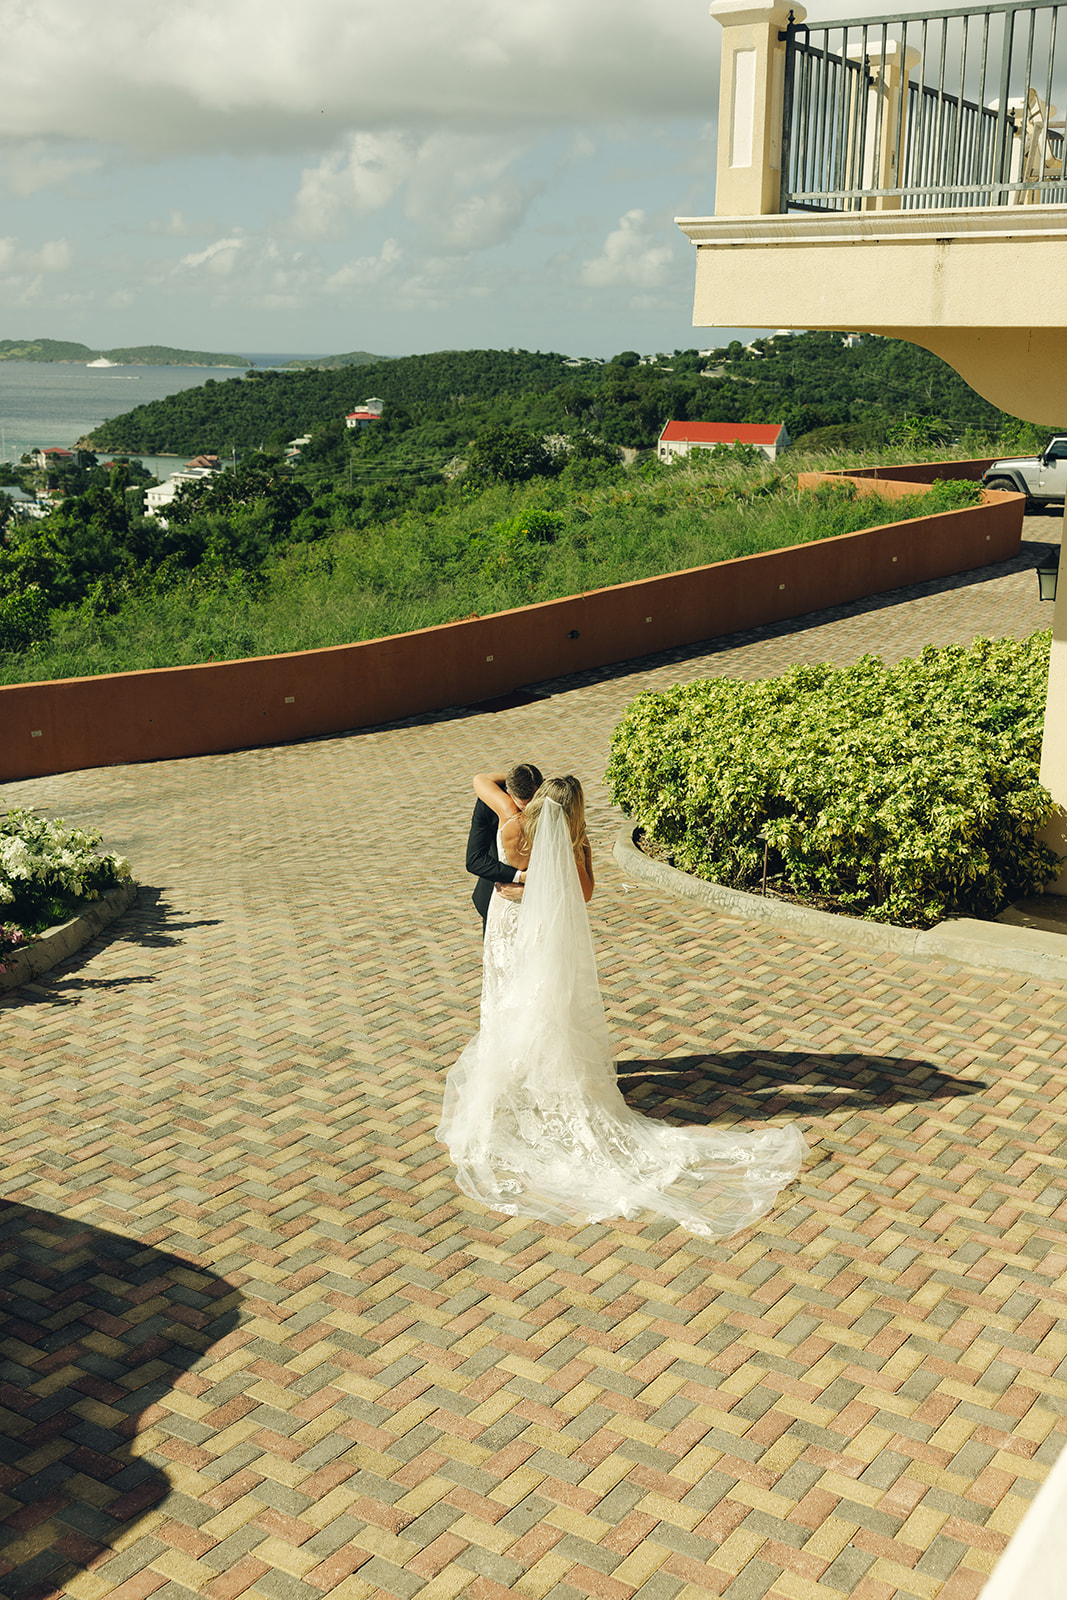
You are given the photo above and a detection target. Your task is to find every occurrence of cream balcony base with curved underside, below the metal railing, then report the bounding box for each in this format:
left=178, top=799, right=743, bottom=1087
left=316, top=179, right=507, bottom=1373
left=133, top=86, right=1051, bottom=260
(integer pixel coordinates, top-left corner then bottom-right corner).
left=678, top=206, right=1067, bottom=422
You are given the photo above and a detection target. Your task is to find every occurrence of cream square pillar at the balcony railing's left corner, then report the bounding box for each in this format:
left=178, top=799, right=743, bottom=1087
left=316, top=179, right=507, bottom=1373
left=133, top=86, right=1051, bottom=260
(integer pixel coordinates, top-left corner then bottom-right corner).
left=712, top=0, right=806, bottom=216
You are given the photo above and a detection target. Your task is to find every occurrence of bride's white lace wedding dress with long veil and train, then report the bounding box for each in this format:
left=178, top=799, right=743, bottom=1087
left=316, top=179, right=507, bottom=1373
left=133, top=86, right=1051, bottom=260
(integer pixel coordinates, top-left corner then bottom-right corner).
left=437, top=800, right=806, bottom=1238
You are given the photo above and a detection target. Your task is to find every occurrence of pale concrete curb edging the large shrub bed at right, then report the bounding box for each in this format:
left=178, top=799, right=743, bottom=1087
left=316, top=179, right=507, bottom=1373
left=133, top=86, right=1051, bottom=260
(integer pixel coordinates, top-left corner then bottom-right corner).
left=613, top=822, right=1067, bottom=982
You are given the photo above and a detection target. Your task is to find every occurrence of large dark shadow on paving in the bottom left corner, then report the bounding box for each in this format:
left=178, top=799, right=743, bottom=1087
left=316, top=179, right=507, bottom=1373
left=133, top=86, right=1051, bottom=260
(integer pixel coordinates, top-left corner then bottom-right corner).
left=0, top=1203, right=240, bottom=1600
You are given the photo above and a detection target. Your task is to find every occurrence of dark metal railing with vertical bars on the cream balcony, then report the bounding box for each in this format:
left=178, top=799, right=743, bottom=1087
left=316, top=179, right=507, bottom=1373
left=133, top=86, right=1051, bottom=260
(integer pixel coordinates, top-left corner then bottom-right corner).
left=781, top=0, right=1067, bottom=211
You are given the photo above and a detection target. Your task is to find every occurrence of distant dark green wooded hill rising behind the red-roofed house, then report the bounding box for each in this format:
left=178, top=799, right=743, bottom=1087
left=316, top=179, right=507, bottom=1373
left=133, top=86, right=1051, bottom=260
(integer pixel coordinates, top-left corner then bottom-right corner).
left=86, top=333, right=1043, bottom=464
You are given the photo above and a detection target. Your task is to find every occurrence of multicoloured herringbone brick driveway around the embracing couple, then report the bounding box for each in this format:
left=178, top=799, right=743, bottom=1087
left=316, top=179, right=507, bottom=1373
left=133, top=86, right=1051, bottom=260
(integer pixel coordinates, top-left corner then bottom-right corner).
left=0, top=517, right=1067, bottom=1600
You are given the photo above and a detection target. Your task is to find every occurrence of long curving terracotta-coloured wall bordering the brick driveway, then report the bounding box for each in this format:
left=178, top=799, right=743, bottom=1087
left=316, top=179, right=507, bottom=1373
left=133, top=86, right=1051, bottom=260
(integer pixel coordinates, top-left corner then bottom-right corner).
left=0, top=489, right=1022, bottom=781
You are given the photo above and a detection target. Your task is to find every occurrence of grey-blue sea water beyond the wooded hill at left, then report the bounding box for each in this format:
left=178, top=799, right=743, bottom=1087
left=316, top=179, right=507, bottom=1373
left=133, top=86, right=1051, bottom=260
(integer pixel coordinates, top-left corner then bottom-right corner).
left=0, top=354, right=321, bottom=477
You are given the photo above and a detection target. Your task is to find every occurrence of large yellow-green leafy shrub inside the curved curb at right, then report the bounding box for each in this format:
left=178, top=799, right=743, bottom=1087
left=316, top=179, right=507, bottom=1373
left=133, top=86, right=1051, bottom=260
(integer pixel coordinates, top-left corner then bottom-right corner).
left=608, top=634, right=1057, bottom=926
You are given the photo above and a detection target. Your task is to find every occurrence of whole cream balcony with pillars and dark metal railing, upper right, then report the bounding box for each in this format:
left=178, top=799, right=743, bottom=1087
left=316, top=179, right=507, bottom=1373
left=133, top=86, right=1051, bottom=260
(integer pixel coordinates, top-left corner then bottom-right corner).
left=678, top=0, right=1067, bottom=421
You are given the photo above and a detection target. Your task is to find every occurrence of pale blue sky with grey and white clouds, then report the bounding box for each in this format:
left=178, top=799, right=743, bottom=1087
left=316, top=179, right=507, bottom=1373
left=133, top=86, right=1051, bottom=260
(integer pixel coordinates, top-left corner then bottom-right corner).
left=0, top=0, right=755, bottom=355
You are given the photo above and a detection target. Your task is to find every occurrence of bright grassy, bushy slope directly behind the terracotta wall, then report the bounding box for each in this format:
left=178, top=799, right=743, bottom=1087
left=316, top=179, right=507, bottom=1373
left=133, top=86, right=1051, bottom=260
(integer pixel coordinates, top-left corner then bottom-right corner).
left=0, top=458, right=974, bottom=683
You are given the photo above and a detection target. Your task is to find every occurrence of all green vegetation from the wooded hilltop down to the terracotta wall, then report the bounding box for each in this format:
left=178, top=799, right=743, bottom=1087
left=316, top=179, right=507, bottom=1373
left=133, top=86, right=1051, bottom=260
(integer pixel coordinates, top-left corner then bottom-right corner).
left=0, top=334, right=1049, bottom=682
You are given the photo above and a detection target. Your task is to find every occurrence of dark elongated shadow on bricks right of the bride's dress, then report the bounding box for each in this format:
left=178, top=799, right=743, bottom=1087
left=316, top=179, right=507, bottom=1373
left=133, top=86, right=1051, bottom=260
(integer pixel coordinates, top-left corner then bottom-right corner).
left=616, top=1050, right=987, bottom=1123
